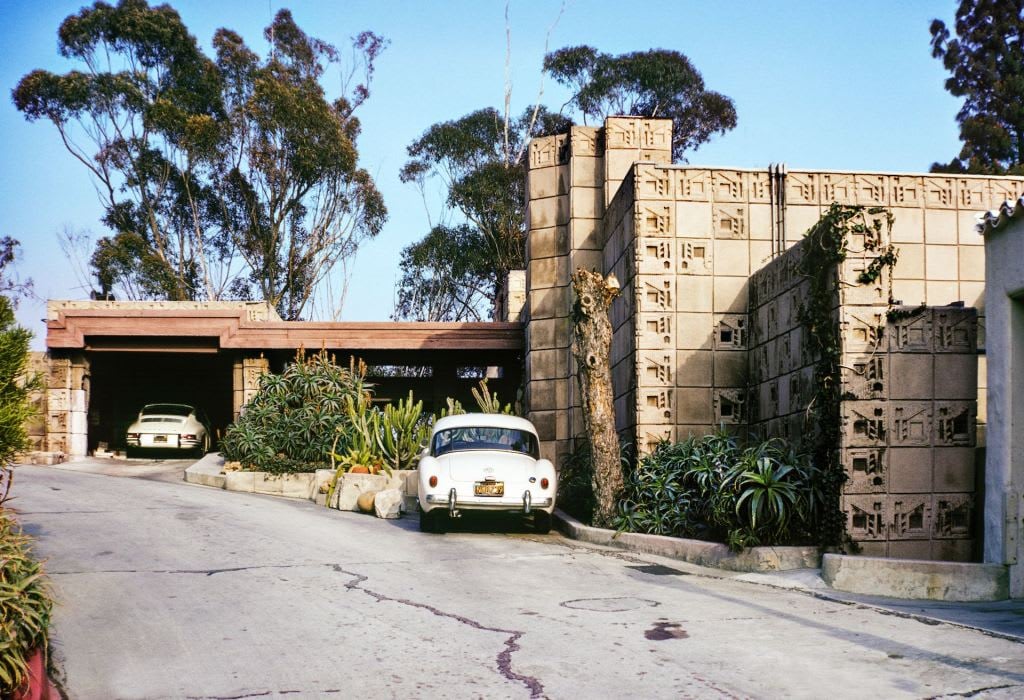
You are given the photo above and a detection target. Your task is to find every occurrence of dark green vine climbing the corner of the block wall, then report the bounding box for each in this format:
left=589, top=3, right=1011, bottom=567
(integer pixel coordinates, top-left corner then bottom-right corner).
left=799, top=203, right=899, bottom=546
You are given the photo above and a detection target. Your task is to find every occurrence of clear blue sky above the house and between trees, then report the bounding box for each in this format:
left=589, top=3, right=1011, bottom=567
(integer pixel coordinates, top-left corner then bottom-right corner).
left=0, top=0, right=959, bottom=347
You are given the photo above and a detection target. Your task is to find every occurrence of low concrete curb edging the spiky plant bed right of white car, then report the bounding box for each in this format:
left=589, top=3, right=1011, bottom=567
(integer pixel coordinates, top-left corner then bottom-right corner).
left=555, top=510, right=821, bottom=572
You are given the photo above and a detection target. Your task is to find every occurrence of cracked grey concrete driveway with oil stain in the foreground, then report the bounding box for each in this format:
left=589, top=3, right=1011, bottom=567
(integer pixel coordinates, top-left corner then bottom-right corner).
left=12, top=467, right=1024, bottom=698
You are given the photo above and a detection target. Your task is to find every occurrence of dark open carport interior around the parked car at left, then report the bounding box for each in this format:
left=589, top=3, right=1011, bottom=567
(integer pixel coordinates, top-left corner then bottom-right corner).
left=88, top=352, right=232, bottom=450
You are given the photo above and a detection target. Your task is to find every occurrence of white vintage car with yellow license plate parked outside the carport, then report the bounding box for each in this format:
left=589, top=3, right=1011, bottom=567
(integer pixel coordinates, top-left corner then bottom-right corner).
left=419, top=413, right=558, bottom=532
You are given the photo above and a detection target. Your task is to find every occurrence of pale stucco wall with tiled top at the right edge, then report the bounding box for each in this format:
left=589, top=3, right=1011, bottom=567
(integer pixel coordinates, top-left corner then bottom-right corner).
left=983, top=198, right=1024, bottom=598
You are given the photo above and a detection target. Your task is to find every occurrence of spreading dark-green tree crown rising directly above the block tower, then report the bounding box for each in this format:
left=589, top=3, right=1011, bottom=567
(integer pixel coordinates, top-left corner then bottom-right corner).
left=544, top=46, right=736, bottom=160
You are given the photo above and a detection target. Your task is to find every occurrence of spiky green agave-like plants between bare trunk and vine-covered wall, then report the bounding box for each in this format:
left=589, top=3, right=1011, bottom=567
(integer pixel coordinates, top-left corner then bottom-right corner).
left=616, top=432, right=821, bottom=550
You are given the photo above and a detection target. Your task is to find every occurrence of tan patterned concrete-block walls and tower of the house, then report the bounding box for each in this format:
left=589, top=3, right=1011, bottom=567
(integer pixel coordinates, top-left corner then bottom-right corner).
left=526, top=118, right=1024, bottom=559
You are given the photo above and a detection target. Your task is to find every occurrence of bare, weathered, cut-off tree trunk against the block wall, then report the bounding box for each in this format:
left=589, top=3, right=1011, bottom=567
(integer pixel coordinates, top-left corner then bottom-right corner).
left=572, top=267, right=623, bottom=527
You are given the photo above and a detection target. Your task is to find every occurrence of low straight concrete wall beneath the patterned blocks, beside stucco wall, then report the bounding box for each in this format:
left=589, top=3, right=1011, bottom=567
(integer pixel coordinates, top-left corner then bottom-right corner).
left=821, top=554, right=1010, bottom=602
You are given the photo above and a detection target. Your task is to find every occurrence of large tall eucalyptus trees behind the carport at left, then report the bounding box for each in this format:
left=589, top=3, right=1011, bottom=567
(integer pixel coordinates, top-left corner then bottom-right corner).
left=12, top=0, right=386, bottom=318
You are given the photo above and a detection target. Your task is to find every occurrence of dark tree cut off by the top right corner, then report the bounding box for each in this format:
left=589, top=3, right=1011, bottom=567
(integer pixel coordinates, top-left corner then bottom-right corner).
left=931, top=0, right=1024, bottom=175
